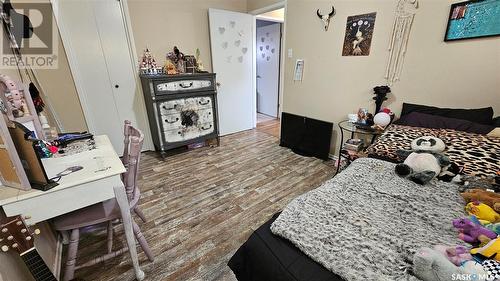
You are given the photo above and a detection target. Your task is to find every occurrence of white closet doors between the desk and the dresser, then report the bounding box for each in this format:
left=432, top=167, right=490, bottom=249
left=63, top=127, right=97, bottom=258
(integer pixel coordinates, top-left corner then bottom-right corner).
left=54, top=0, right=151, bottom=154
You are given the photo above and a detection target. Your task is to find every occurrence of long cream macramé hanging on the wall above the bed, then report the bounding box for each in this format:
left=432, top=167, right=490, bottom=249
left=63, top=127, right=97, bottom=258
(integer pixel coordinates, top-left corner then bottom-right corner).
left=385, top=0, right=418, bottom=86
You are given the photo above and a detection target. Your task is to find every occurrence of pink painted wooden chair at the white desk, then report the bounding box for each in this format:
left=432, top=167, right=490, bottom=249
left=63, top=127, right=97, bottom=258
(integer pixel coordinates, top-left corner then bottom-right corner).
left=52, top=121, right=154, bottom=281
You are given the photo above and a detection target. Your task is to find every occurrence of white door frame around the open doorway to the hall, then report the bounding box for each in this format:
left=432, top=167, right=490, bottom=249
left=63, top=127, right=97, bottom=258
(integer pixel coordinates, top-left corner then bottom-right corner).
left=248, top=0, right=288, bottom=121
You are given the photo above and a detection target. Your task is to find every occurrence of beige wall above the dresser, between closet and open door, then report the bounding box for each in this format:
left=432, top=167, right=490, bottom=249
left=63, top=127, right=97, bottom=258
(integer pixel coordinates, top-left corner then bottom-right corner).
left=128, top=0, right=247, bottom=71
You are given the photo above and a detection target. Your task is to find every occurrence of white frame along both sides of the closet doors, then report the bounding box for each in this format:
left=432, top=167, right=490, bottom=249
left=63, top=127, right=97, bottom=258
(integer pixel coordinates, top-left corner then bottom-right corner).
left=50, top=0, right=154, bottom=151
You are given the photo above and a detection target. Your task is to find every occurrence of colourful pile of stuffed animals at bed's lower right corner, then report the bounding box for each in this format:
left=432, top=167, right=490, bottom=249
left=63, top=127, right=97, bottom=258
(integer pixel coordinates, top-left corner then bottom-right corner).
left=413, top=189, right=500, bottom=281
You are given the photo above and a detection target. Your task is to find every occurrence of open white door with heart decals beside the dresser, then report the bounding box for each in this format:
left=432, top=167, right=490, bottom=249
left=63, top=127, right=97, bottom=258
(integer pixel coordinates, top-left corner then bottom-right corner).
left=208, top=9, right=256, bottom=135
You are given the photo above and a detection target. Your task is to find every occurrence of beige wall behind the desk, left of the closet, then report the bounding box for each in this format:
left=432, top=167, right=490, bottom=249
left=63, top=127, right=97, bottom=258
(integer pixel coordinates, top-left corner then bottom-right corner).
left=0, top=0, right=87, bottom=132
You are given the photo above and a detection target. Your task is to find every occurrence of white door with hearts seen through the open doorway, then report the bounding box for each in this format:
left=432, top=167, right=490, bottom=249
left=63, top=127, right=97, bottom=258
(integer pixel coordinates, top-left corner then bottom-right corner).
left=256, top=23, right=281, bottom=117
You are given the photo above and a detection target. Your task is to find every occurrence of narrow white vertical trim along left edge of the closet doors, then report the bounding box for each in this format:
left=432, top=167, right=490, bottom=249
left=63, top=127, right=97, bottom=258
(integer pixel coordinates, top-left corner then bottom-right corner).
left=50, top=0, right=95, bottom=132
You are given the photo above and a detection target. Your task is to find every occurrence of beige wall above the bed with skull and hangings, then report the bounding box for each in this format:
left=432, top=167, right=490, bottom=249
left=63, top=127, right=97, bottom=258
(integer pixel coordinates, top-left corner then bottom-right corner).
left=283, top=0, right=500, bottom=153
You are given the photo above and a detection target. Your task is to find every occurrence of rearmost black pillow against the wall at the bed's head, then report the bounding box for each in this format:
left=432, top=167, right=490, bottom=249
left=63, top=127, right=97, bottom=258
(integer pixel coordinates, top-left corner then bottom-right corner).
left=401, top=103, right=493, bottom=125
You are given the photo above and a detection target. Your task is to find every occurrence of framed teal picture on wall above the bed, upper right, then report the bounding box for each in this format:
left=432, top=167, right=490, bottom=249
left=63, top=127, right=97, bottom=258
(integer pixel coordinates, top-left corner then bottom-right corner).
left=444, top=0, right=500, bottom=41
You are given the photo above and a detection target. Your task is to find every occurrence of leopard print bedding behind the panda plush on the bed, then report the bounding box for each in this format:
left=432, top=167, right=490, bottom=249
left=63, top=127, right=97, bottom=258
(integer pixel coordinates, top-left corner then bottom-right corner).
left=367, top=125, right=500, bottom=179
